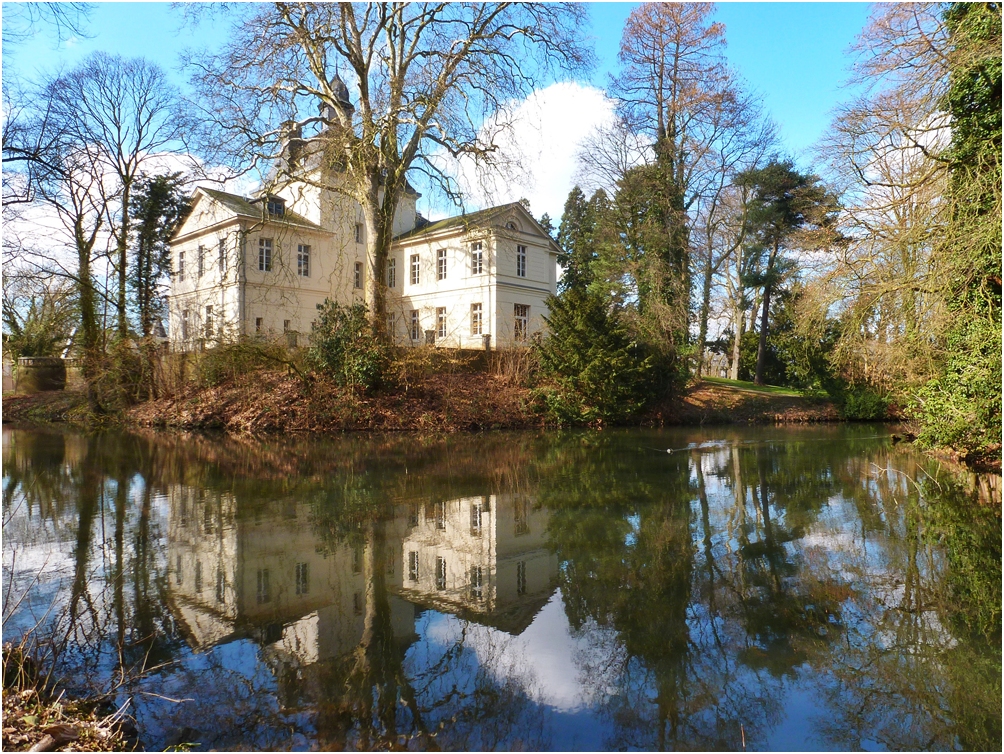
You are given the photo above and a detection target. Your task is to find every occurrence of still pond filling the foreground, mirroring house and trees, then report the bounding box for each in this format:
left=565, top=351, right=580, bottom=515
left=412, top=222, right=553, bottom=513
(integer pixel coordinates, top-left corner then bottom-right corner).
left=3, top=425, right=1001, bottom=751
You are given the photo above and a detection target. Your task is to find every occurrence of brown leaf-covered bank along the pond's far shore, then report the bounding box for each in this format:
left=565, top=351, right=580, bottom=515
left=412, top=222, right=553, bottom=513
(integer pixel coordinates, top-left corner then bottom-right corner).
left=3, top=370, right=839, bottom=435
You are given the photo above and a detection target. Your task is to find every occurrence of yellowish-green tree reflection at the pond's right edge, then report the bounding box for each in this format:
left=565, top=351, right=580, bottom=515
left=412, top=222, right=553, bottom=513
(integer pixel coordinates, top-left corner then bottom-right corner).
left=816, top=469, right=1001, bottom=751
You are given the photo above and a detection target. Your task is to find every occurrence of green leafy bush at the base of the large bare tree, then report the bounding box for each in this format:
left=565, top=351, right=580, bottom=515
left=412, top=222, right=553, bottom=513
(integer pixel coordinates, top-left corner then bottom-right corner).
left=307, top=299, right=391, bottom=390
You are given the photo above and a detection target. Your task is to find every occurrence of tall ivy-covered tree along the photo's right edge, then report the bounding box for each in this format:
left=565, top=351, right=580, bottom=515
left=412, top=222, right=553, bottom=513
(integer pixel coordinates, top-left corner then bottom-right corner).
left=913, top=3, right=1001, bottom=460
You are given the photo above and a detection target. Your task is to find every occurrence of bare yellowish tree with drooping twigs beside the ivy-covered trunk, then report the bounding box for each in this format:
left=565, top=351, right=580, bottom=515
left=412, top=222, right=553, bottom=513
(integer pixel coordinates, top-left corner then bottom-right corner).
left=812, top=3, right=951, bottom=385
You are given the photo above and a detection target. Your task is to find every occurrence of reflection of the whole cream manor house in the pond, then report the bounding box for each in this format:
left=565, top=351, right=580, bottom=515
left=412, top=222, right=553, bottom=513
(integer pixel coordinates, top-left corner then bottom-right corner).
left=168, top=486, right=557, bottom=665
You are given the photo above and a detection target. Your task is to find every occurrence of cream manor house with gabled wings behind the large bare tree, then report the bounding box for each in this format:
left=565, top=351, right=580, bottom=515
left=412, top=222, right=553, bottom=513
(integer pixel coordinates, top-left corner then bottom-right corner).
left=169, top=102, right=558, bottom=350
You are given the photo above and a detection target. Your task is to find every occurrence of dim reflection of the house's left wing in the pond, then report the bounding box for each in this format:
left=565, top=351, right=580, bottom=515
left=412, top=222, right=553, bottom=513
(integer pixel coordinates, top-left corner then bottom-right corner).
left=168, top=487, right=414, bottom=663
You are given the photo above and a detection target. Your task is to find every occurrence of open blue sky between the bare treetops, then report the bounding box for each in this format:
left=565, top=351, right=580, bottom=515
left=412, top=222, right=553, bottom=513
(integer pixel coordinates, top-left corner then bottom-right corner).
left=4, top=2, right=869, bottom=215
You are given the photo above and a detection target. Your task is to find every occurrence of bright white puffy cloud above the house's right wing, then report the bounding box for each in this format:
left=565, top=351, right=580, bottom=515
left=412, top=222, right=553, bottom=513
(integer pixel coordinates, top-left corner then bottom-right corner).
left=437, top=82, right=615, bottom=225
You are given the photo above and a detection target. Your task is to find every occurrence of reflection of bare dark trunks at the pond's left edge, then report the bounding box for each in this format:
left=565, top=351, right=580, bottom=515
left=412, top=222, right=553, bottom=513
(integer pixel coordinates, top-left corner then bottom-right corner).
left=4, top=433, right=181, bottom=704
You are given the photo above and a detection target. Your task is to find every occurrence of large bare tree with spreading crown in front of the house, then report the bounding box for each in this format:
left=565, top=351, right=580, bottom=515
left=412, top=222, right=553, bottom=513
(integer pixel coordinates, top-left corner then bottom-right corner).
left=189, top=3, right=589, bottom=332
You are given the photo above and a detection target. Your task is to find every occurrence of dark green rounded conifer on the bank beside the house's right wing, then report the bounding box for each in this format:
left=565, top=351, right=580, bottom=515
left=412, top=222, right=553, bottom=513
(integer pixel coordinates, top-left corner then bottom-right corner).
left=534, top=288, right=656, bottom=424
